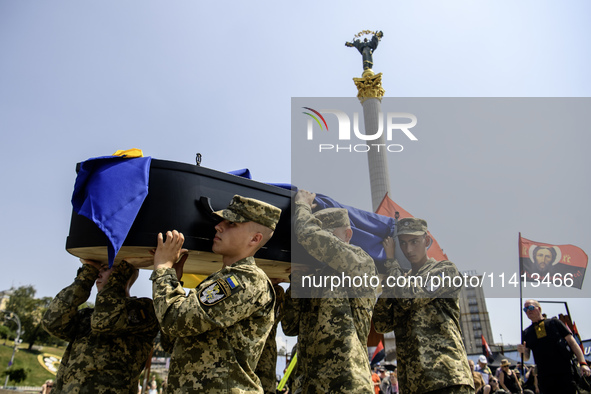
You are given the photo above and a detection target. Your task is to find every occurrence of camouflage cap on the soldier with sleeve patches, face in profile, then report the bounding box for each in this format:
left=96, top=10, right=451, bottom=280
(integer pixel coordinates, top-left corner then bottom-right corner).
left=213, top=194, right=281, bottom=231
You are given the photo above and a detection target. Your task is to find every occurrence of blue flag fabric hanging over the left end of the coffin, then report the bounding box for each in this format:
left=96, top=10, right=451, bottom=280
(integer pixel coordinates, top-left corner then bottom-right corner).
left=72, top=156, right=152, bottom=268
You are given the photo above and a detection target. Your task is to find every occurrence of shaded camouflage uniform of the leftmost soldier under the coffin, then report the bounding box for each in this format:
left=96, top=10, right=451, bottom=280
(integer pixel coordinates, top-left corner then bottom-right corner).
left=43, top=262, right=158, bottom=394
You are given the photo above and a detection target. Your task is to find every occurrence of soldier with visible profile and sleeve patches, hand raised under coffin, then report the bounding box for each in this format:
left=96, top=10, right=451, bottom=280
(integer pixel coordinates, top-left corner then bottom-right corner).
left=150, top=195, right=281, bottom=393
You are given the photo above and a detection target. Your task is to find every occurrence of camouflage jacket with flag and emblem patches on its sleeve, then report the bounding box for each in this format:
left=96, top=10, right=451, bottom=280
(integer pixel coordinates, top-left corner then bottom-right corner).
left=150, top=257, right=275, bottom=393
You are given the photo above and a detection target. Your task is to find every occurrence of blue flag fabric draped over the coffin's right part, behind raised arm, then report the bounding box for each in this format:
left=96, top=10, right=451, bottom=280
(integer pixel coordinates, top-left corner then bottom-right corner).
left=230, top=169, right=396, bottom=262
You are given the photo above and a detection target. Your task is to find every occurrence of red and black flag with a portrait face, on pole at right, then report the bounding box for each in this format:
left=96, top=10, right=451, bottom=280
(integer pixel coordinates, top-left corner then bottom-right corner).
left=519, top=234, right=588, bottom=289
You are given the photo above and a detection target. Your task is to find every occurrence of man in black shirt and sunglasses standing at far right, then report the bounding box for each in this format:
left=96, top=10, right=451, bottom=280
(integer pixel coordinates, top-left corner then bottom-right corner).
left=517, top=300, right=591, bottom=394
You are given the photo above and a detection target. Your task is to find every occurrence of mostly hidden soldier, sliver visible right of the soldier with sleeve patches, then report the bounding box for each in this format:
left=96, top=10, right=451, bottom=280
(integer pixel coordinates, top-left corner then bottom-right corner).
left=254, top=280, right=285, bottom=394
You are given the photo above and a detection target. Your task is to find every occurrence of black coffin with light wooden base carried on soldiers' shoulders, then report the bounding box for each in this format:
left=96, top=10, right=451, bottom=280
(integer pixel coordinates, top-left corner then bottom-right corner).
left=66, top=159, right=292, bottom=280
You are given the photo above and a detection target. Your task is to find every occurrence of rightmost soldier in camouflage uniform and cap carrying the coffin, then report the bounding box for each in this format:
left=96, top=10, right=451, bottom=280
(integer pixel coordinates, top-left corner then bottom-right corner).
left=373, top=218, right=474, bottom=394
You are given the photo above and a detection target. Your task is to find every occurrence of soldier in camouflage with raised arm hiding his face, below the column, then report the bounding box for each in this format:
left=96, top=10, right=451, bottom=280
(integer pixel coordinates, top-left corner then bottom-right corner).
left=281, top=190, right=376, bottom=394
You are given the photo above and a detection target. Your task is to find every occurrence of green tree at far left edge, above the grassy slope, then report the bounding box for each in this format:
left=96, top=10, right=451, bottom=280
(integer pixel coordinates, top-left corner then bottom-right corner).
left=6, top=285, right=51, bottom=350
